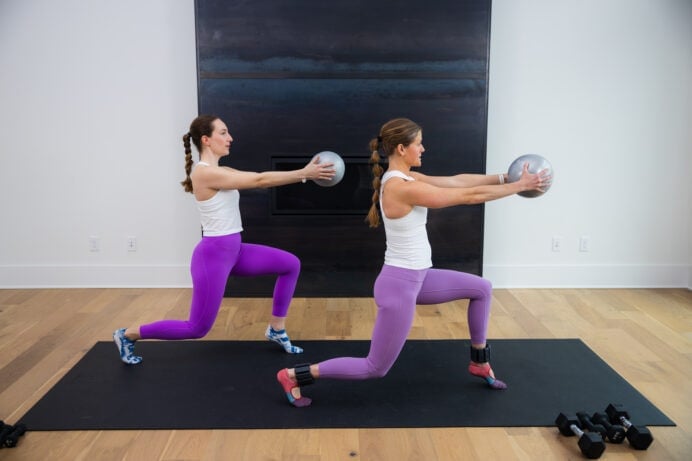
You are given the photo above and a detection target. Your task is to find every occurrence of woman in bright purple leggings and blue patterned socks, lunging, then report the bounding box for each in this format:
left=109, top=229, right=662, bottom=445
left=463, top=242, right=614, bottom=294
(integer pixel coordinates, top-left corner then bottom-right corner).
left=113, top=115, right=335, bottom=365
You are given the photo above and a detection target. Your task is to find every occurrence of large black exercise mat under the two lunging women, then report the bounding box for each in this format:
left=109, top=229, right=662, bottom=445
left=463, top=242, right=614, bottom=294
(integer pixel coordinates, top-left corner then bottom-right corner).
left=21, top=339, right=675, bottom=430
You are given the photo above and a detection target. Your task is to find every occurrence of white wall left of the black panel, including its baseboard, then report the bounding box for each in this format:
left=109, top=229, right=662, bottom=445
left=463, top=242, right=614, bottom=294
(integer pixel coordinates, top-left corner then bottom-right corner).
left=0, top=0, right=199, bottom=287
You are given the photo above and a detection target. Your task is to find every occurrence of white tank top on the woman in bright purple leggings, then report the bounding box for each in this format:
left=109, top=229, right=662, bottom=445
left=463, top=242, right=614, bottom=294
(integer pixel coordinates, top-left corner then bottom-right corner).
left=195, top=162, right=243, bottom=237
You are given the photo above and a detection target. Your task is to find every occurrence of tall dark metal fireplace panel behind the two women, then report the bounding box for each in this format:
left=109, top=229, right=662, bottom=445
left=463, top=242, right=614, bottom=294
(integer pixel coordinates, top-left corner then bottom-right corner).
left=195, top=0, right=490, bottom=297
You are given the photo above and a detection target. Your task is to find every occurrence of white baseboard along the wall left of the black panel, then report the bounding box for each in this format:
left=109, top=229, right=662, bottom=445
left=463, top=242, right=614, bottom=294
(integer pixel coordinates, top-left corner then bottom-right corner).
left=0, top=265, right=192, bottom=288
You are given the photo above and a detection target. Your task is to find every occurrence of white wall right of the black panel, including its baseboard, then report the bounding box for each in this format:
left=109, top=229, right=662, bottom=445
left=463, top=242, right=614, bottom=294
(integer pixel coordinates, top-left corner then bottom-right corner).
left=484, top=0, right=692, bottom=287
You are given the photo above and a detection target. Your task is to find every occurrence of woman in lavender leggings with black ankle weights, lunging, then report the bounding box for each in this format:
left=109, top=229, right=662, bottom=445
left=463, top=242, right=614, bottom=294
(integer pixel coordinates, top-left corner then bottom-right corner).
left=277, top=118, right=550, bottom=407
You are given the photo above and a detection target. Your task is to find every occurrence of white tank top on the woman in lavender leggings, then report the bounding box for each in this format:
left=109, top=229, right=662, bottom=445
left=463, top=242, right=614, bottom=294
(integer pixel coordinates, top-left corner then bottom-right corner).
left=380, top=170, right=432, bottom=270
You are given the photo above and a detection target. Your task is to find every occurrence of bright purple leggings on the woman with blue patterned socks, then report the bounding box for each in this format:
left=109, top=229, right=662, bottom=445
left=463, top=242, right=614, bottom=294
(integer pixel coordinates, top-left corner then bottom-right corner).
left=139, top=233, right=300, bottom=339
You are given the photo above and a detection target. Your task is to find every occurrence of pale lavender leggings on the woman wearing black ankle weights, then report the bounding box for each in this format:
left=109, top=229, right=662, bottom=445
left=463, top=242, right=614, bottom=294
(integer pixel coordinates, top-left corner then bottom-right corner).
left=319, top=265, right=492, bottom=379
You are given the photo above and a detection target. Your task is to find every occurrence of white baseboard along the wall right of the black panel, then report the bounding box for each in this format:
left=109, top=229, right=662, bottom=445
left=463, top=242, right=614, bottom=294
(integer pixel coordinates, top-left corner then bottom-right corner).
left=483, top=264, right=692, bottom=289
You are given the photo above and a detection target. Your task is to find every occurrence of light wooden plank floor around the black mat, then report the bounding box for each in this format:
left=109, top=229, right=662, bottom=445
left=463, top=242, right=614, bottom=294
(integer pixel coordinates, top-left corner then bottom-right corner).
left=0, top=289, right=692, bottom=461
